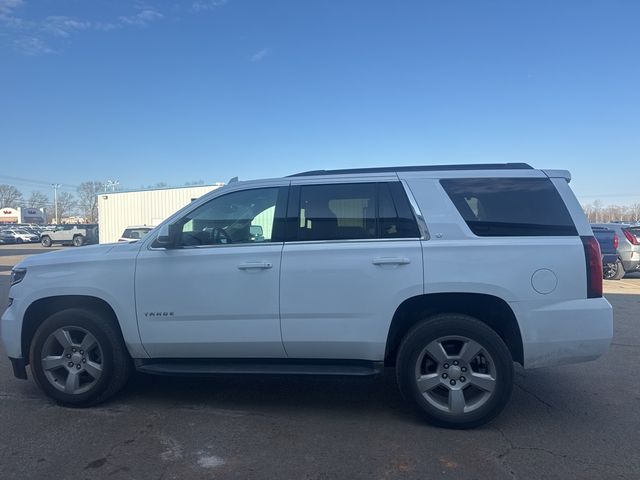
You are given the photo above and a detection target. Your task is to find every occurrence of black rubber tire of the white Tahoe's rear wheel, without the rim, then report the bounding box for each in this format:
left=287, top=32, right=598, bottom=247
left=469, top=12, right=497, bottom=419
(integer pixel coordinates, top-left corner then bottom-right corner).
left=396, top=315, right=513, bottom=428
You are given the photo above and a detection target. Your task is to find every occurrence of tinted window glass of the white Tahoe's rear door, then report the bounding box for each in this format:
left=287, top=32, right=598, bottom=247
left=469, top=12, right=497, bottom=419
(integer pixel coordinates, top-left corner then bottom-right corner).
left=292, top=182, right=420, bottom=241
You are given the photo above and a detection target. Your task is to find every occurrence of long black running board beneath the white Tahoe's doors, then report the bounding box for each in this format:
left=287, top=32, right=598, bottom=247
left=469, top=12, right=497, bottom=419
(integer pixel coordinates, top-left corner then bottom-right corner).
left=135, top=358, right=384, bottom=376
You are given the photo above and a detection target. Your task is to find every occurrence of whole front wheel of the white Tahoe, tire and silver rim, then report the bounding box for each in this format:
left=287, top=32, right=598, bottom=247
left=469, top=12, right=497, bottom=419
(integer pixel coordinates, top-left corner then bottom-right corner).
left=29, top=308, right=131, bottom=407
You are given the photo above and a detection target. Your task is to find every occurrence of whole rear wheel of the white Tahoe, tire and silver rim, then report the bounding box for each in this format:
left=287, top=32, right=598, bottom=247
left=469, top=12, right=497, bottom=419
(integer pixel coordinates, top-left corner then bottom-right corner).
left=396, top=314, right=513, bottom=429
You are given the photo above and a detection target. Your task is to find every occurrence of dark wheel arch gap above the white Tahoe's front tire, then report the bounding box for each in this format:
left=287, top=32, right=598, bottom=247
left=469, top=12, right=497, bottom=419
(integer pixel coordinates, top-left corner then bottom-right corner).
left=20, top=295, right=124, bottom=361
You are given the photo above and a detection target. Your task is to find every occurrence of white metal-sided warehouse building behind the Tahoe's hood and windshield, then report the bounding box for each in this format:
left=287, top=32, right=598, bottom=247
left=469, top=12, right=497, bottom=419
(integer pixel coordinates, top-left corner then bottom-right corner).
left=98, top=183, right=223, bottom=243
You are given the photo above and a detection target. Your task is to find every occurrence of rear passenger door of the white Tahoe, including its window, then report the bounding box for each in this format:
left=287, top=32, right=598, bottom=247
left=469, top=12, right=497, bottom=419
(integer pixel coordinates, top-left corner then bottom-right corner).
left=280, top=179, right=423, bottom=360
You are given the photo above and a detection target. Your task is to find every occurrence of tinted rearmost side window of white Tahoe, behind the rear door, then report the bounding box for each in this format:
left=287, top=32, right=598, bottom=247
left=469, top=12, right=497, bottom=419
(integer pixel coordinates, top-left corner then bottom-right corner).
left=440, top=178, right=578, bottom=237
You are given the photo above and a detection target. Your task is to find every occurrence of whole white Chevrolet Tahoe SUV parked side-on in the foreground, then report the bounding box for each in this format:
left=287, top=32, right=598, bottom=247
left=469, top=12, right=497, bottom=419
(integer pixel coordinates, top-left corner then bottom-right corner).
left=1, top=164, right=613, bottom=428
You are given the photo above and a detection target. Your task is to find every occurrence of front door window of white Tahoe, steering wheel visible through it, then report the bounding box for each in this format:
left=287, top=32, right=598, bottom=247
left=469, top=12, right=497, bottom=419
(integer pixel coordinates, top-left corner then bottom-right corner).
left=178, top=187, right=278, bottom=246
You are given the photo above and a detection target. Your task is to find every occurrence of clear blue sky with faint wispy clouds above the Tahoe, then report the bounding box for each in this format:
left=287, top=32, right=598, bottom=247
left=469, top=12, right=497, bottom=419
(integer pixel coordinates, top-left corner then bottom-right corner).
left=0, top=0, right=640, bottom=203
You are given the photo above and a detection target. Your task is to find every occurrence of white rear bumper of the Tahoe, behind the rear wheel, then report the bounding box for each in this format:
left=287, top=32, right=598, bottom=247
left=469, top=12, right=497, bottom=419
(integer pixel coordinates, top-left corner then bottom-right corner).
left=511, top=298, right=613, bottom=368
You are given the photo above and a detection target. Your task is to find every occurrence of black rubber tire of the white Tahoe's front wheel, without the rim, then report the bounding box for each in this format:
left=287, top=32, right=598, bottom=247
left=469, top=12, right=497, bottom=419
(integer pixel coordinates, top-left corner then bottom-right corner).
left=29, top=308, right=132, bottom=407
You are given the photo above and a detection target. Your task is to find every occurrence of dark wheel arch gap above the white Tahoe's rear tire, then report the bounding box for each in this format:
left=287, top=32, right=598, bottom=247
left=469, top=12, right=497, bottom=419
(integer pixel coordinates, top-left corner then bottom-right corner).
left=385, top=292, right=524, bottom=365
